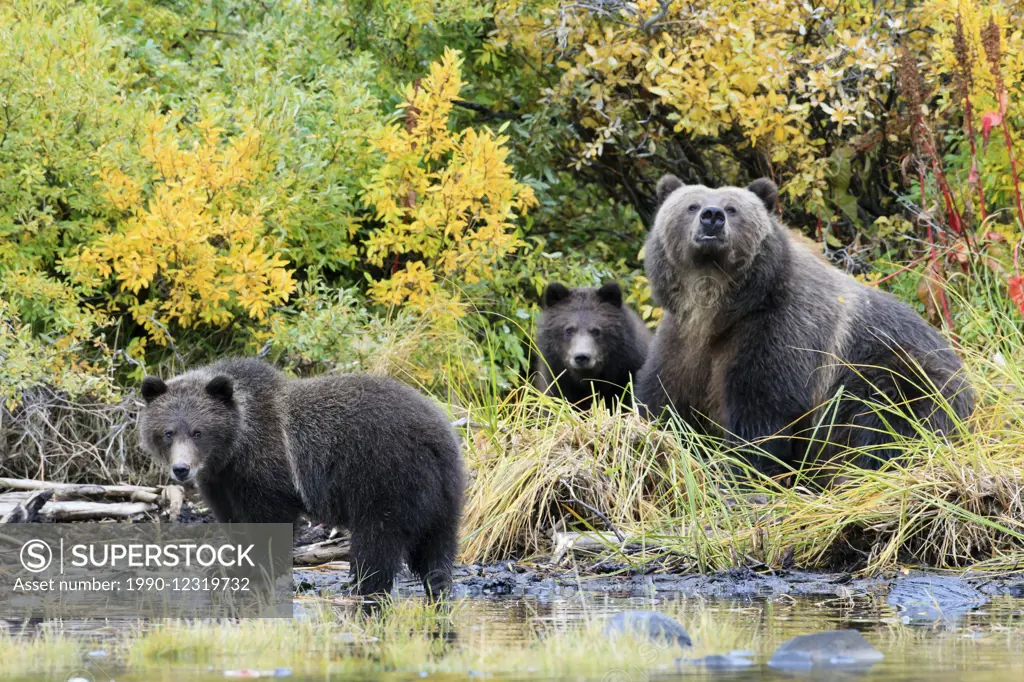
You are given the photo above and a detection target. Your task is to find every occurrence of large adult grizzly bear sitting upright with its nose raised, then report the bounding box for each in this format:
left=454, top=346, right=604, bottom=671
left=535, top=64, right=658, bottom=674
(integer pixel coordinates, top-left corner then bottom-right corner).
left=637, top=175, right=974, bottom=472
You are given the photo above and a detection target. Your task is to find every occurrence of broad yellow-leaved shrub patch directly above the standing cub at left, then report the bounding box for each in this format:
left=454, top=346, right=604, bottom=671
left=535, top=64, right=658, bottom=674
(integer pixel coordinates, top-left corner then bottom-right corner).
left=66, top=116, right=295, bottom=341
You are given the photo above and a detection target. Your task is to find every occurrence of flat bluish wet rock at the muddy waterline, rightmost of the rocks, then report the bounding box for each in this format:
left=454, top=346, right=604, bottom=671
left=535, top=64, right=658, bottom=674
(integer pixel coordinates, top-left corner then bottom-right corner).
left=887, top=576, right=988, bottom=623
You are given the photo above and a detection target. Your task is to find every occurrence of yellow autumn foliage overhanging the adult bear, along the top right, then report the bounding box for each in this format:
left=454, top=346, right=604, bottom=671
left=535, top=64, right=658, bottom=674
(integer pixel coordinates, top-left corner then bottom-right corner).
left=489, top=0, right=1024, bottom=220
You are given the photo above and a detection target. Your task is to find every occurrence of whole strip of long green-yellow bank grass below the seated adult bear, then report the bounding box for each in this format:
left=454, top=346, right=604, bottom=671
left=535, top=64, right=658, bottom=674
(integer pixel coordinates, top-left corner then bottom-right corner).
left=449, top=292, right=1024, bottom=571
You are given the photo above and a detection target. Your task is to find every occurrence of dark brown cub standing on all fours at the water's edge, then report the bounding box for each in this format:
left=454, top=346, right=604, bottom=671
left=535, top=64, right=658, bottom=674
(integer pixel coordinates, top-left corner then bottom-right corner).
left=139, top=359, right=464, bottom=598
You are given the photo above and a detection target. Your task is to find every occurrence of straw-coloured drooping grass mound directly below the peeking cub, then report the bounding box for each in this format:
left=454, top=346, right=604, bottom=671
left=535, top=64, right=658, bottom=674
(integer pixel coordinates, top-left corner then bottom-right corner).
left=463, top=389, right=720, bottom=561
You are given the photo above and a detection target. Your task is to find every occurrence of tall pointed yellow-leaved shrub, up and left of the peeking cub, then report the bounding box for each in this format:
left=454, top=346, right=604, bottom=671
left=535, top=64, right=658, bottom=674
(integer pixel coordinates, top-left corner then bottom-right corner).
left=364, top=49, right=537, bottom=312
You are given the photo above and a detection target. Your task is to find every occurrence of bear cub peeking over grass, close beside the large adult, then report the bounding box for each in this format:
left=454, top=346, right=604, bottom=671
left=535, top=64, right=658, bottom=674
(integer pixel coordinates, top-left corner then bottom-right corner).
left=536, top=282, right=651, bottom=410
